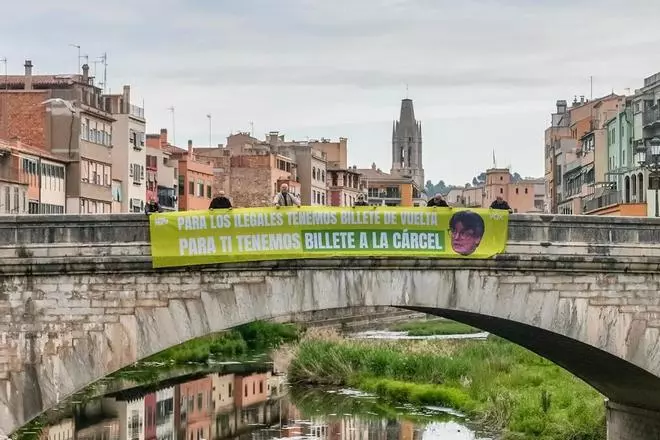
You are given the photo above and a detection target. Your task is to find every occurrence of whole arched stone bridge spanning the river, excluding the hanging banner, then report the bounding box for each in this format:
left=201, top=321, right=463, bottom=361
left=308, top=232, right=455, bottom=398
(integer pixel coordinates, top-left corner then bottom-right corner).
left=0, top=215, right=660, bottom=440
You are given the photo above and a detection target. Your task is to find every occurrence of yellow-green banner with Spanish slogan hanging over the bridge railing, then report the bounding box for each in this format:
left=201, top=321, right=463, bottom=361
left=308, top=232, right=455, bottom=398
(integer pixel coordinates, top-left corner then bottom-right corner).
left=149, top=206, right=509, bottom=267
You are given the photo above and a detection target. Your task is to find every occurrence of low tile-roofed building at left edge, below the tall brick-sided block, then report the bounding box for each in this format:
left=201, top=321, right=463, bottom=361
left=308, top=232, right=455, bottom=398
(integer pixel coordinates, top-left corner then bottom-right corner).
left=0, top=139, right=67, bottom=214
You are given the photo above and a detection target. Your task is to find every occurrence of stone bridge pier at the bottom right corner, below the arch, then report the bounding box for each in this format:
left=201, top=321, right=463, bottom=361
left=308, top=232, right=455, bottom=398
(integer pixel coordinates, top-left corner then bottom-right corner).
left=605, top=401, right=660, bottom=440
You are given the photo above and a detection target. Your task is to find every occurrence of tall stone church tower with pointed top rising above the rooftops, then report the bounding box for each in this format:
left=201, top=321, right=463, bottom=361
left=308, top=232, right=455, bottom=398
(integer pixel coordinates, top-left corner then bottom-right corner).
left=390, top=98, right=425, bottom=191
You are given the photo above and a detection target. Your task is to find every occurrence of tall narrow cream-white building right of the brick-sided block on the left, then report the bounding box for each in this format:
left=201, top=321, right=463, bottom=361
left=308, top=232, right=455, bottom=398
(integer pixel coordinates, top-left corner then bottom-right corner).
left=103, top=85, right=146, bottom=212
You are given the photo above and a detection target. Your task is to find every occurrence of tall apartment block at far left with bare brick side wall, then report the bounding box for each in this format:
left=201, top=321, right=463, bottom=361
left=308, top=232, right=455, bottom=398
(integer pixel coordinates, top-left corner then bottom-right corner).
left=0, top=60, right=115, bottom=213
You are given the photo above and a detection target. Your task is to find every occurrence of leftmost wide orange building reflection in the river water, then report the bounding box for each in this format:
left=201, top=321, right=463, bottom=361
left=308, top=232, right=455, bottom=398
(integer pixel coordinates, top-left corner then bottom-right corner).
left=179, top=375, right=213, bottom=440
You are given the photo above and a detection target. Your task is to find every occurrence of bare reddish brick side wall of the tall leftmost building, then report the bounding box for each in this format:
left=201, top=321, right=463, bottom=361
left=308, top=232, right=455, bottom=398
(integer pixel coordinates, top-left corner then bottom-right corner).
left=0, top=91, right=49, bottom=148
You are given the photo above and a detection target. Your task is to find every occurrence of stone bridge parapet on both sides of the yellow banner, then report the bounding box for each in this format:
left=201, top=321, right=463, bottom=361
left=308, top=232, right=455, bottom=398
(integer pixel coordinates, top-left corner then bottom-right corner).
left=0, top=214, right=660, bottom=275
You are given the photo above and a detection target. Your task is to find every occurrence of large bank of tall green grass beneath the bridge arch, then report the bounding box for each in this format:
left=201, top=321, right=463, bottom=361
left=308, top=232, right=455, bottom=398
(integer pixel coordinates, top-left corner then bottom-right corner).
left=289, top=338, right=605, bottom=440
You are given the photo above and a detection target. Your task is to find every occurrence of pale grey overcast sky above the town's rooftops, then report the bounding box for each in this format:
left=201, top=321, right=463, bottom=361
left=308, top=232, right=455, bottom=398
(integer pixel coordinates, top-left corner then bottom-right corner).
left=0, top=0, right=660, bottom=184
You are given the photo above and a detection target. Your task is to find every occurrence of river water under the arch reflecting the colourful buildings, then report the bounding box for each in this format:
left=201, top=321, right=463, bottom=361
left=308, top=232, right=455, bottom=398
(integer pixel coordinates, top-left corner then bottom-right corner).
left=32, top=366, right=490, bottom=440
